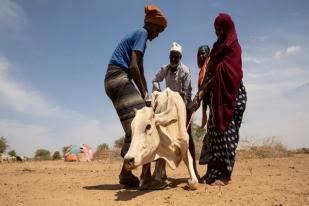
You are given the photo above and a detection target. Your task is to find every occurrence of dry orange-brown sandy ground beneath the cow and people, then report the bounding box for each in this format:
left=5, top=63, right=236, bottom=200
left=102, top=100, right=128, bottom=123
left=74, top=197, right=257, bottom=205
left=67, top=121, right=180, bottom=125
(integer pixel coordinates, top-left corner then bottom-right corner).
left=0, top=154, right=309, bottom=206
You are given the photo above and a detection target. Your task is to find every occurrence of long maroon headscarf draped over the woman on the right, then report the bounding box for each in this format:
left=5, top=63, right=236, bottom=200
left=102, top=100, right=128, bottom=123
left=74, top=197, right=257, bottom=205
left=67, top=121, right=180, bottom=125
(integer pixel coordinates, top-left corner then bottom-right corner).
left=209, top=13, right=243, bottom=131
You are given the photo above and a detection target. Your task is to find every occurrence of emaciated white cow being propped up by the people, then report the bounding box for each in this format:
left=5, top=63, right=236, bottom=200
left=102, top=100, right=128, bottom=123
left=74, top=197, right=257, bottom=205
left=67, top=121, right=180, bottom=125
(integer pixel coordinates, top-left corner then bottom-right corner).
left=124, top=88, right=198, bottom=189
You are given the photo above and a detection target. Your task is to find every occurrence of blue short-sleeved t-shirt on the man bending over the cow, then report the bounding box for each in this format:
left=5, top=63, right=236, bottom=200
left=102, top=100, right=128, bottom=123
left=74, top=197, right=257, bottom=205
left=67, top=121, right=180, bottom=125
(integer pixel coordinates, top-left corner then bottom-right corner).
left=109, top=28, right=148, bottom=69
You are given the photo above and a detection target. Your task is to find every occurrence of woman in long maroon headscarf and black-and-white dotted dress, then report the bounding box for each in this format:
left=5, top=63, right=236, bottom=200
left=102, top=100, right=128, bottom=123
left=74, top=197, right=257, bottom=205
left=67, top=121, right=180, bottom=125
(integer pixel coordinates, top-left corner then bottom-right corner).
left=193, top=13, right=247, bottom=186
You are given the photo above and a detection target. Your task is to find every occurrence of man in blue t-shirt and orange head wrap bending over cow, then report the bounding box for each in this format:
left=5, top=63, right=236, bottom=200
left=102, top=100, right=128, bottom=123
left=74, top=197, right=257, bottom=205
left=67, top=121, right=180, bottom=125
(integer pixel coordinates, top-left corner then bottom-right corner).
left=104, top=5, right=167, bottom=187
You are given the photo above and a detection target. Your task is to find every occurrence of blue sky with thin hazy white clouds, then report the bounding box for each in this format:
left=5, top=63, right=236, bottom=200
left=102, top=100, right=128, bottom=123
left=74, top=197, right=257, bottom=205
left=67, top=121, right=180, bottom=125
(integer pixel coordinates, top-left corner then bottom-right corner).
left=0, top=0, right=309, bottom=156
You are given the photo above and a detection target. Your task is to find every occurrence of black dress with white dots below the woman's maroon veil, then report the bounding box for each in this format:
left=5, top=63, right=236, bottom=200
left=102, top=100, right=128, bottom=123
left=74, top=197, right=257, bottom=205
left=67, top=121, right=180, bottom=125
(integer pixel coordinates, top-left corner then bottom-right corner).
left=200, top=83, right=247, bottom=184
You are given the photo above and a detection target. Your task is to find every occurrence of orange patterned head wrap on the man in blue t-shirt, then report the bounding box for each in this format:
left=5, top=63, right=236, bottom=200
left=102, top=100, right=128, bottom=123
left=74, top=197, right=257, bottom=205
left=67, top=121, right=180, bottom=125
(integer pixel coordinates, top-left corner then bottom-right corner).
left=145, top=5, right=167, bottom=28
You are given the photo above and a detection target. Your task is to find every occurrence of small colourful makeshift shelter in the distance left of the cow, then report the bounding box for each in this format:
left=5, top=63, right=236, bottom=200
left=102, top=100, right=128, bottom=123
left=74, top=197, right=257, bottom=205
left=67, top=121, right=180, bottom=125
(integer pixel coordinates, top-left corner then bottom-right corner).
left=64, top=144, right=93, bottom=162
